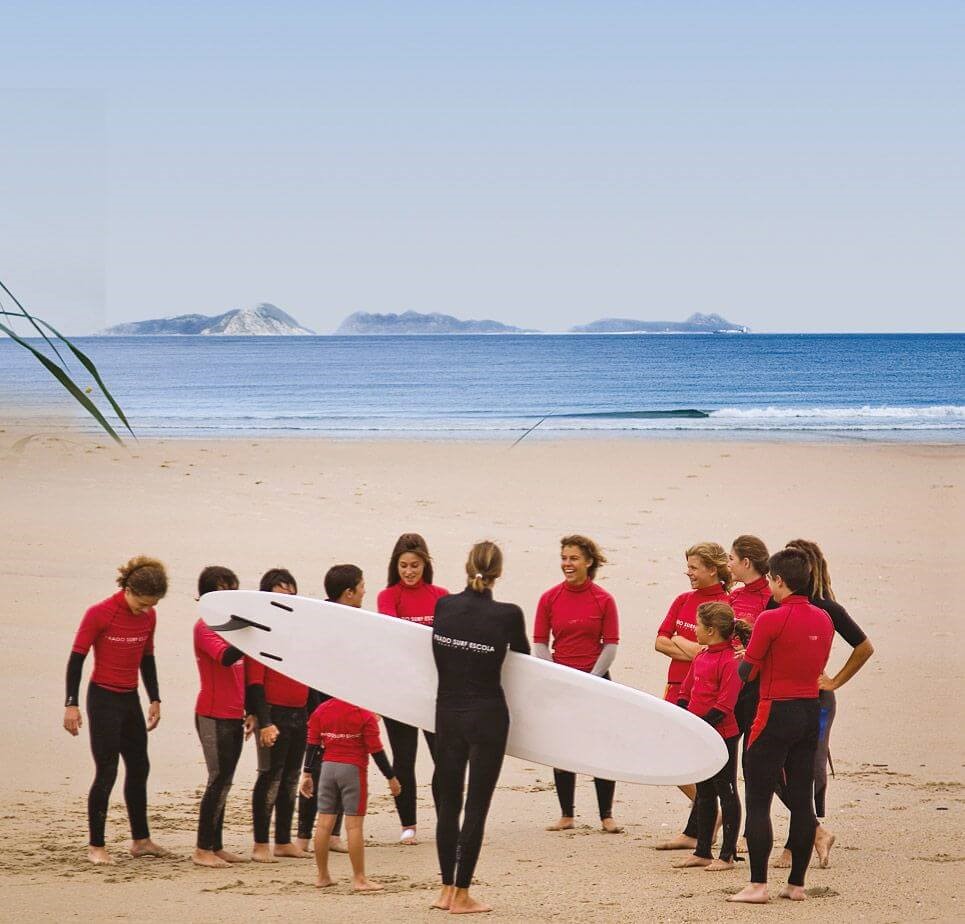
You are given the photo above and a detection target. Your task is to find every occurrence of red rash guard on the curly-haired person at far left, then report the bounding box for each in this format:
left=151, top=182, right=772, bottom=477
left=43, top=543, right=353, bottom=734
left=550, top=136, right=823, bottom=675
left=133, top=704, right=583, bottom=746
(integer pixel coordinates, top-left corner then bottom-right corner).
left=71, top=590, right=157, bottom=693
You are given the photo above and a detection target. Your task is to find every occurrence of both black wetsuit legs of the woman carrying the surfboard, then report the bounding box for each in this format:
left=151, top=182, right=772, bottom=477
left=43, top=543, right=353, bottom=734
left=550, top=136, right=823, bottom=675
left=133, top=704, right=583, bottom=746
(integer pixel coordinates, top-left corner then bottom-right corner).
left=433, top=705, right=509, bottom=889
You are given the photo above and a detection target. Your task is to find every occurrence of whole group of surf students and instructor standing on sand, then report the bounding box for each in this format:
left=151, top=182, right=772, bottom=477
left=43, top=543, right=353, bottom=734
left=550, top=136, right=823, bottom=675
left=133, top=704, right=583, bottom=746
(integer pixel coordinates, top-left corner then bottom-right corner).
left=64, top=533, right=873, bottom=913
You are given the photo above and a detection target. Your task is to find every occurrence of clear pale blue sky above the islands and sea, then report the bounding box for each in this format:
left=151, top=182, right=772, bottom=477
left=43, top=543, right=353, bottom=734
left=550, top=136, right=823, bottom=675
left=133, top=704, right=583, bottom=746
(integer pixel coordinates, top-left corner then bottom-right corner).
left=0, top=0, right=965, bottom=334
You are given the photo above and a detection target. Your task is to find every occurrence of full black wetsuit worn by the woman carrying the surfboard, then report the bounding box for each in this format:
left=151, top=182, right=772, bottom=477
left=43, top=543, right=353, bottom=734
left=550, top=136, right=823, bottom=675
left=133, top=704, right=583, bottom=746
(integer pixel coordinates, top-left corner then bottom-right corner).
left=432, top=588, right=529, bottom=889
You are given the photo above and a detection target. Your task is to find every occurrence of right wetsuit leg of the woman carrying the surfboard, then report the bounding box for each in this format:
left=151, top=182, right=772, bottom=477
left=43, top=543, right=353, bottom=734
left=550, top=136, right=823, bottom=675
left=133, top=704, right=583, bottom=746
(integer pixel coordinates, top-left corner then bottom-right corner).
left=456, top=707, right=509, bottom=889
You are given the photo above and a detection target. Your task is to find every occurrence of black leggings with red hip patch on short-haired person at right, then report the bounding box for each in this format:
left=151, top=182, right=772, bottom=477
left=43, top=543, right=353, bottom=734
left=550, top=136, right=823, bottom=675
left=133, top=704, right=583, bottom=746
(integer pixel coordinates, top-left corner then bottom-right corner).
left=744, top=699, right=820, bottom=886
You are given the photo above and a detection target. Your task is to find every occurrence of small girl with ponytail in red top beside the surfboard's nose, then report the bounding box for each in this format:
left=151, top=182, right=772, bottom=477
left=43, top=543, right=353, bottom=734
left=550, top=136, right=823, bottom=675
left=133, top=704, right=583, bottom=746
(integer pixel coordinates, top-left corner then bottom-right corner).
left=674, top=603, right=751, bottom=872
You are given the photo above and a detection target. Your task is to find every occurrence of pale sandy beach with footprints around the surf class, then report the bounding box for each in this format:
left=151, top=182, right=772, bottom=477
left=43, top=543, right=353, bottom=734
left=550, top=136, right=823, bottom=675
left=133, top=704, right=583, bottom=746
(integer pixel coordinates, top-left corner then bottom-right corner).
left=0, top=429, right=965, bottom=924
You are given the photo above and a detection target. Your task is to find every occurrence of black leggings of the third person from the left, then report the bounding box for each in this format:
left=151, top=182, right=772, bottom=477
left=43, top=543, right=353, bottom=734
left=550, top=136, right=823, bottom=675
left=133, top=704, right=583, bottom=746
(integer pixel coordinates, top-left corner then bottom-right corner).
left=251, top=703, right=306, bottom=844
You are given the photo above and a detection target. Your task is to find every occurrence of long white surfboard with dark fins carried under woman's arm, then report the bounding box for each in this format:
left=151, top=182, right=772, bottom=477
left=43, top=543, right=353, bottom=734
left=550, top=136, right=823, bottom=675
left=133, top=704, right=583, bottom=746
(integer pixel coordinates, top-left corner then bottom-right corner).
left=199, top=590, right=727, bottom=785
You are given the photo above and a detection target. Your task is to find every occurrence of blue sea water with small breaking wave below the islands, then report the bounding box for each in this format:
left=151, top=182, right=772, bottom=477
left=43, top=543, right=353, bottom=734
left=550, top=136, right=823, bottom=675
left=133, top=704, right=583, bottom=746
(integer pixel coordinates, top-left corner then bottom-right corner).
left=0, top=334, right=965, bottom=442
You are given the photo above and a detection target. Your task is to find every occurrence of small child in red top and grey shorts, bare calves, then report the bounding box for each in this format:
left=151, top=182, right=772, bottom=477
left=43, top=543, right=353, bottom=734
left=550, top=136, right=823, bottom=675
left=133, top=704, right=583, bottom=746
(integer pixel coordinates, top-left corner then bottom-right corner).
left=299, top=699, right=401, bottom=892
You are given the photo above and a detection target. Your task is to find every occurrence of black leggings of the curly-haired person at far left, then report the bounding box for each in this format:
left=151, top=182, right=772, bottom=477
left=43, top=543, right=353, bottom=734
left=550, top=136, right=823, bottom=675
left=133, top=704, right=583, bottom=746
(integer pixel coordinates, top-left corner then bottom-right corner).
left=87, top=683, right=151, bottom=847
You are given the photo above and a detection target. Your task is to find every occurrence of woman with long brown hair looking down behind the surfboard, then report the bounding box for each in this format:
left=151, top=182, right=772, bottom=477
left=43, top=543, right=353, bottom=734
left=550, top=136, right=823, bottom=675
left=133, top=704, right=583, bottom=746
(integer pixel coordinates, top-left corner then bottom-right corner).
left=378, top=533, right=449, bottom=845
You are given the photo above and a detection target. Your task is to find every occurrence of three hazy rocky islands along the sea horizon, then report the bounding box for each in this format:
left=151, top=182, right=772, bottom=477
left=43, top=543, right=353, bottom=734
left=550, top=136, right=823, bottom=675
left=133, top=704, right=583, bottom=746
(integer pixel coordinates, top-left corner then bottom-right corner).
left=95, top=302, right=750, bottom=337
